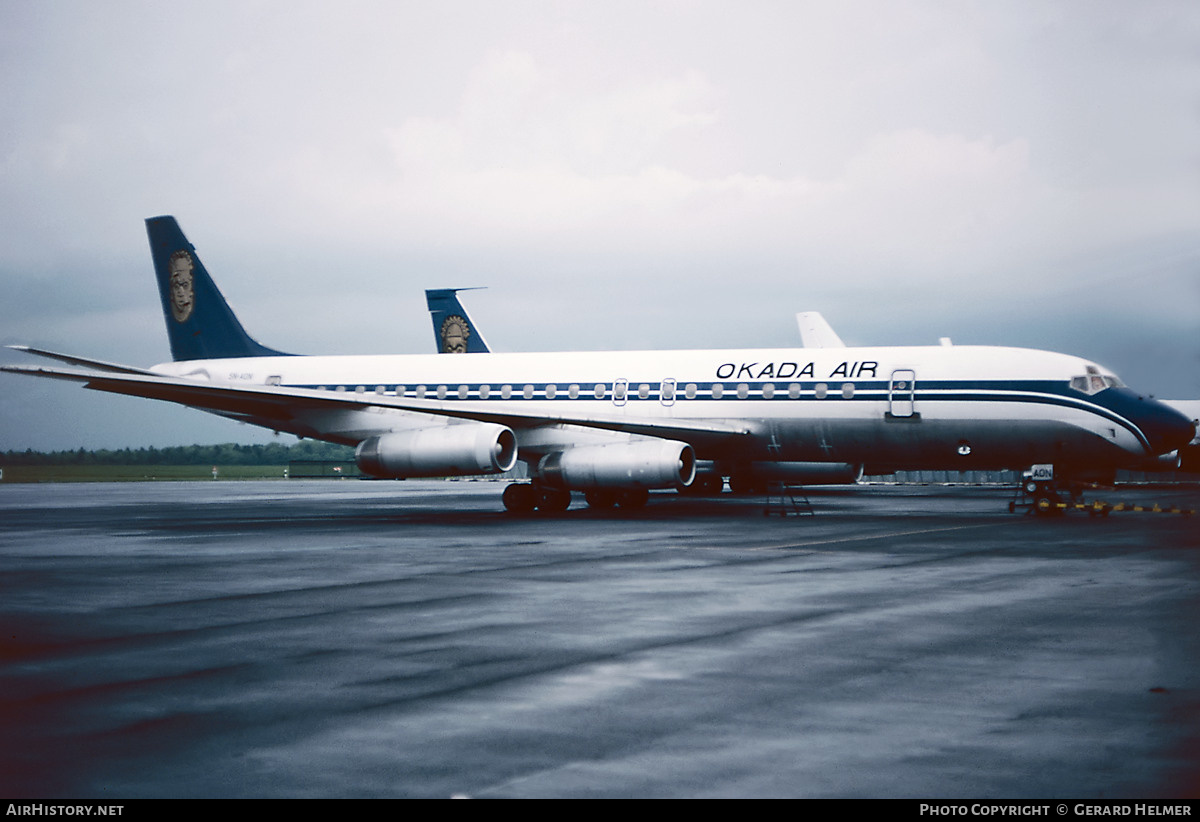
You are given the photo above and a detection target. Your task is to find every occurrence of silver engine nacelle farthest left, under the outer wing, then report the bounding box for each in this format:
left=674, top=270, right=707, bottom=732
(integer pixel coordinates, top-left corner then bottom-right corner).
left=354, top=422, right=517, bottom=479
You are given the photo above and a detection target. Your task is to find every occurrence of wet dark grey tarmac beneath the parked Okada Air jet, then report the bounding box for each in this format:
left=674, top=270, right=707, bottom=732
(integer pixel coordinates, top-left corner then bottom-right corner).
left=0, top=480, right=1200, bottom=799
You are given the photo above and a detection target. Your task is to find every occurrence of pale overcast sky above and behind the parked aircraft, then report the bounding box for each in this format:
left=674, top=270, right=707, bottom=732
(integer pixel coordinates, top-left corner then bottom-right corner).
left=0, top=0, right=1200, bottom=450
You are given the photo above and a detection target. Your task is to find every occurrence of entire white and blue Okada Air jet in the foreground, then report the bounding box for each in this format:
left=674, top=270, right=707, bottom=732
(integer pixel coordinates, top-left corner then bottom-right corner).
left=4, top=216, right=1194, bottom=511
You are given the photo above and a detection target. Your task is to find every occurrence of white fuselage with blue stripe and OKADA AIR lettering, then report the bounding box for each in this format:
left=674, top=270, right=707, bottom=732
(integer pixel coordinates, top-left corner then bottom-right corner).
left=154, top=346, right=1193, bottom=472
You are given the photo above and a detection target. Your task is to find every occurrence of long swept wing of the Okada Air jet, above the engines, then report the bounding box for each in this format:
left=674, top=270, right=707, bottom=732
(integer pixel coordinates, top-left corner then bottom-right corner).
left=0, top=366, right=750, bottom=445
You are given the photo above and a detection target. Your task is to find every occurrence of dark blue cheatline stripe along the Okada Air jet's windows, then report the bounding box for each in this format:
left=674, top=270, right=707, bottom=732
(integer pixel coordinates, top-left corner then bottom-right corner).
left=285, top=380, right=1150, bottom=450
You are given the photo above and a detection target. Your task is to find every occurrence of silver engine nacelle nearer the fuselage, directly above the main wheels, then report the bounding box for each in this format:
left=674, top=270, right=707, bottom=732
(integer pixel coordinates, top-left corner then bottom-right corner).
left=538, top=439, right=696, bottom=491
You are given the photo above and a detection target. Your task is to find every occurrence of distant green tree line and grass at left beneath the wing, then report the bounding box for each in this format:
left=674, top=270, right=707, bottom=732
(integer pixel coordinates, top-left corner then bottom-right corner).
left=0, top=439, right=354, bottom=466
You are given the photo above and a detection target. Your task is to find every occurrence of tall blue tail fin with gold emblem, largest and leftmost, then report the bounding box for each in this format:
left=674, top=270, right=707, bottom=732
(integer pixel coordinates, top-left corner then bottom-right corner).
left=146, top=217, right=286, bottom=361
